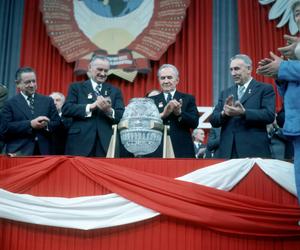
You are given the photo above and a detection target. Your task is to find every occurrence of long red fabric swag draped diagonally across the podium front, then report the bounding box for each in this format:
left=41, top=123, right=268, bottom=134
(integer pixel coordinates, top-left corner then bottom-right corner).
left=0, top=157, right=300, bottom=237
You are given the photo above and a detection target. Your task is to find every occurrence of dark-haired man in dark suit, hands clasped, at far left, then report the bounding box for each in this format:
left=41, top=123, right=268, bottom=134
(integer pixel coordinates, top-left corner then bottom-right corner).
left=2, top=67, right=60, bottom=155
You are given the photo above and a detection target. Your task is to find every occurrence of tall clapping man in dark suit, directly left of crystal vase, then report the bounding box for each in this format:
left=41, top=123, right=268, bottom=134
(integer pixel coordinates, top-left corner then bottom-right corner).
left=62, top=55, right=124, bottom=157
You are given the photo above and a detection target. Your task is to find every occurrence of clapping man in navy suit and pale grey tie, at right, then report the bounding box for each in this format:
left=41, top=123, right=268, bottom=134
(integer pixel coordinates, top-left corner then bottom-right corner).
left=210, top=54, right=275, bottom=158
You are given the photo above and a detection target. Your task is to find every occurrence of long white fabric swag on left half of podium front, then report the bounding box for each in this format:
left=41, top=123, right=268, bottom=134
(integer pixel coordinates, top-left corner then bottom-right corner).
left=0, top=189, right=159, bottom=230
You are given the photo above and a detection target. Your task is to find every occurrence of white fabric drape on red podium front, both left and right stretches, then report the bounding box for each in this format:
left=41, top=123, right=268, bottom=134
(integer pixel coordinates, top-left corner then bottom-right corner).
left=0, top=158, right=296, bottom=230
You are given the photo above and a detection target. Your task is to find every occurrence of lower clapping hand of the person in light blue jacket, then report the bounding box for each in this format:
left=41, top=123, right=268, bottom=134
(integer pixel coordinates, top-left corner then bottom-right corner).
left=256, top=52, right=283, bottom=78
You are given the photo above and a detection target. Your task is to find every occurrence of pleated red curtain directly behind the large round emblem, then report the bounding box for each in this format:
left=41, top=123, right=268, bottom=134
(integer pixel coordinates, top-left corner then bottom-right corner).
left=21, top=0, right=212, bottom=106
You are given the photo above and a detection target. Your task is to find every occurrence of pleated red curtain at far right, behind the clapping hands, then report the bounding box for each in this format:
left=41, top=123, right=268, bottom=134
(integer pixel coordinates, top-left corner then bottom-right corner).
left=238, top=0, right=289, bottom=108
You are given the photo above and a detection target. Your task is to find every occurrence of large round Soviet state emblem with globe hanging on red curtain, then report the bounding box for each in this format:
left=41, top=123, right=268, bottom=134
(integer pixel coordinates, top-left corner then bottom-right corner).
left=40, top=0, right=190, bottom=81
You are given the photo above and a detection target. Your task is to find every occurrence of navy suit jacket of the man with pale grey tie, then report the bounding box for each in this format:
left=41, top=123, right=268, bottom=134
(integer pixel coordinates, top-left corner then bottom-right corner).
left=210, top=80, right=275, bottom=158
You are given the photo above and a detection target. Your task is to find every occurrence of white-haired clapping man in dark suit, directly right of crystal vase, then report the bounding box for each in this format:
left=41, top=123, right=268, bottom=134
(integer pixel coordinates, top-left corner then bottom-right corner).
left=151, top=64, right=199, bottom=158
